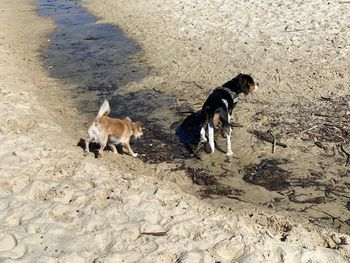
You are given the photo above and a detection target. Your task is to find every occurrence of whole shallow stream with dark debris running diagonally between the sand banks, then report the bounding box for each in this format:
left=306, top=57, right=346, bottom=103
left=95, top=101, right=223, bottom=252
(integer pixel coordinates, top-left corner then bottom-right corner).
left=38, top=0, right=350, bottom=235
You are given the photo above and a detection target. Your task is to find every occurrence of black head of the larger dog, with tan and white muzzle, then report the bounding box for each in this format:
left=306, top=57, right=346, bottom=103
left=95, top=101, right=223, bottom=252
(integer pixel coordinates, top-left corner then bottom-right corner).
left=223, top=73, right=259, bottom=95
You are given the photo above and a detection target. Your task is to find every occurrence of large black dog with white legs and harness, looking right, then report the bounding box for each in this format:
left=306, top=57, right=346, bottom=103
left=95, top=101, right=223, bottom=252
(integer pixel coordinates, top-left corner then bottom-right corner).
left=198, top=74, right=259, bottom=156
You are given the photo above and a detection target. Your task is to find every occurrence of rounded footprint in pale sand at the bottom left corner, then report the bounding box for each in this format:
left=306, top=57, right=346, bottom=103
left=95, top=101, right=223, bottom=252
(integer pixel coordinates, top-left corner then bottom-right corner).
left=0, top=233, right=27, bottom=261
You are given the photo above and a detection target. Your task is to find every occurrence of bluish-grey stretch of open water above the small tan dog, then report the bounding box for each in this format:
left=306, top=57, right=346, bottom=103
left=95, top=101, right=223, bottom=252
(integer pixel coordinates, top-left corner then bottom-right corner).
left=38, top=0, right=147, bottom=92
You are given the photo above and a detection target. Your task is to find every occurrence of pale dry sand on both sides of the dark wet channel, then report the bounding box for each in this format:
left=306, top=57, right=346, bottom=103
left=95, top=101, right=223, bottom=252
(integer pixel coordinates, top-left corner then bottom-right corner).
left=0, top=0, right=350, bottom=263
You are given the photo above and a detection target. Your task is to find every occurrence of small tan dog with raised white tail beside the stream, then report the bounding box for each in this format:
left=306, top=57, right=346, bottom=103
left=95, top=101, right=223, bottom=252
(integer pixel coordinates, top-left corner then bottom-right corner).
left=85, top=100, right=143, bottom=157
